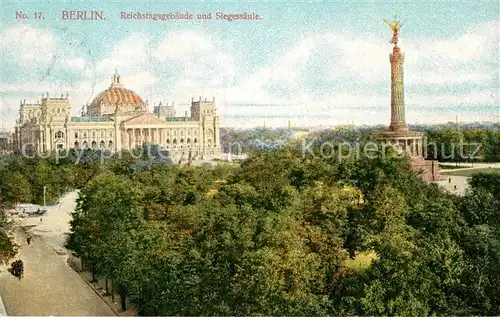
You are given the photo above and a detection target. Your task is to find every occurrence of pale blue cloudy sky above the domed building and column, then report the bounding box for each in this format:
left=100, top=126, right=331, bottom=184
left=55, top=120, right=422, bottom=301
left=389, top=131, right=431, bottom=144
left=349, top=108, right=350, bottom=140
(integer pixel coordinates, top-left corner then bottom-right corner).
left=0, top=0, right=500, bottom=129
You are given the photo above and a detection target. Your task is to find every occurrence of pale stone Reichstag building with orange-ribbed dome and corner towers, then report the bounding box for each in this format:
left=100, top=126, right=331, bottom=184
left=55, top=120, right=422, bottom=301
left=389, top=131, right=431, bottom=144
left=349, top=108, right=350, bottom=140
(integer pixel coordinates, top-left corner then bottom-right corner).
left=14, top=73, right=220, bottom=160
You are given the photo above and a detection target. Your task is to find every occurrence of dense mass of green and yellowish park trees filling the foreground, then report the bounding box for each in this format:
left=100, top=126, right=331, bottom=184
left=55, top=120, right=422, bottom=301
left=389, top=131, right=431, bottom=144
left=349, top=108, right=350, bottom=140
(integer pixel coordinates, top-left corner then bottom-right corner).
left=0, top=130, right=500, bottom=316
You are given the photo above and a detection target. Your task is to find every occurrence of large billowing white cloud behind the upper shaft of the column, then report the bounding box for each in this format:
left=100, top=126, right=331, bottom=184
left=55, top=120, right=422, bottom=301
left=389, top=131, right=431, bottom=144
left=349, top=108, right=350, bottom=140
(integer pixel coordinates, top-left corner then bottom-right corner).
left=229, top=21, right=500, bottom=102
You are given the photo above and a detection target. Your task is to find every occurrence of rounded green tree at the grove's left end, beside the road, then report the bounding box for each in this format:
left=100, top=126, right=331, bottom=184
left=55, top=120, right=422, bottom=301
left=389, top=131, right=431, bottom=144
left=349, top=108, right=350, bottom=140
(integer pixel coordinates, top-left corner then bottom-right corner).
left=66, top=172, right=145, bottom=306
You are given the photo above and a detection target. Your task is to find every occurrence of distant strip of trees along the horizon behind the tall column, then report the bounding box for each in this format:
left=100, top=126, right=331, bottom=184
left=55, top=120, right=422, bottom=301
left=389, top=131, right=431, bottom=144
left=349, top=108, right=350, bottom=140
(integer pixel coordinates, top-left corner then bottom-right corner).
left=221, top=124, right=500, bottom=162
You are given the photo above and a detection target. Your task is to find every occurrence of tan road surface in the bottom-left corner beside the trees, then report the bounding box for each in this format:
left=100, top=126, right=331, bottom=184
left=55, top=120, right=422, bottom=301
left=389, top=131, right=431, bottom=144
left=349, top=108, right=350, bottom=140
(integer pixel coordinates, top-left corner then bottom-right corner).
left=0, top=231, right=114, bottom=316
